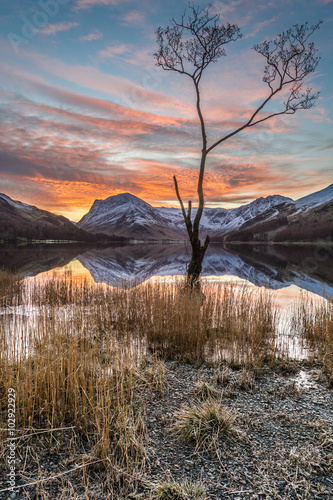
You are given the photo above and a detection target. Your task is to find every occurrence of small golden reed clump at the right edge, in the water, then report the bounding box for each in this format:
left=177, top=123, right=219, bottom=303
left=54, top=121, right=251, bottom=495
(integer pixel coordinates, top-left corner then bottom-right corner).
left=292, top=294, right=333, bottom=388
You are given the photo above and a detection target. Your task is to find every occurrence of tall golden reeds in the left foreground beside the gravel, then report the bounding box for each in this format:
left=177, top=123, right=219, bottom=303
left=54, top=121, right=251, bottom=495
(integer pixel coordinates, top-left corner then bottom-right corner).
left=0, top=276, right=146, bottom=498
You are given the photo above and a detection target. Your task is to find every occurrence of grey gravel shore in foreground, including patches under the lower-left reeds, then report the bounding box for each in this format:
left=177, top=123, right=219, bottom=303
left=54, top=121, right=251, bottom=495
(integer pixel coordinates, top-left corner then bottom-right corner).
left=0, top=361, right=333, bottom=500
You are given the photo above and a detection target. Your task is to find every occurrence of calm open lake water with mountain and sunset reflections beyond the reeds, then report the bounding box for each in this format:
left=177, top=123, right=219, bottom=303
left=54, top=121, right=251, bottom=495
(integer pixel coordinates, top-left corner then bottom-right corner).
left=0, top=244, right=333, bottom=358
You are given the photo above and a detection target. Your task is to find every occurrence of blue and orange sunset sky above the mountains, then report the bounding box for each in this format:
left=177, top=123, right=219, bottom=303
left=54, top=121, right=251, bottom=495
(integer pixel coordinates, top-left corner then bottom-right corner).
left=0, top=0, right=333, bottom=221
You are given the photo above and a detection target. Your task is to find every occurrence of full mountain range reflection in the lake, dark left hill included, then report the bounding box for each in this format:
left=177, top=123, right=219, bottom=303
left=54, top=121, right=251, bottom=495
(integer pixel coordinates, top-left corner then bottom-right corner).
left=0, top=244, right=333, bottom=296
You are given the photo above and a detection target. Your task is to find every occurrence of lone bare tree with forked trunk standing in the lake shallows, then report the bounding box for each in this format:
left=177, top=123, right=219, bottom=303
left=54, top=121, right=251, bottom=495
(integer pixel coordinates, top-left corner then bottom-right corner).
left=154, top=2, right=321, bottom=288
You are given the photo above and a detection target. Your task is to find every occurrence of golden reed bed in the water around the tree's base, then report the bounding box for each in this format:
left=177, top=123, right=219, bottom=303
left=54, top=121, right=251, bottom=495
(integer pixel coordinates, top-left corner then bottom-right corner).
left=25, top=275, right=278, bottom=364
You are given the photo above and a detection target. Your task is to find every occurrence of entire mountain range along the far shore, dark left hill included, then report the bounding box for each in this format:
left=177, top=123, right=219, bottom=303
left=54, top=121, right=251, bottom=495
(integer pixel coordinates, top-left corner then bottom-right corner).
left=0, top=184, right=333, bottom=242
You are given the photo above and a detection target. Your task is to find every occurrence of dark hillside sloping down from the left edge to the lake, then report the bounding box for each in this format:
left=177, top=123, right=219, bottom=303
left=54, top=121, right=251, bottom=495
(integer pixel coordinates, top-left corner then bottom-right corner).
left=0, top=194, right=104, bottom=242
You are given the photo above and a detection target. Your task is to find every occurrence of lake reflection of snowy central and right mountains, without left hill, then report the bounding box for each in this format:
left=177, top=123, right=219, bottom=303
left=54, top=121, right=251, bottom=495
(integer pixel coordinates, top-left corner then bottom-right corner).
left=78, top=245, right=333, bottom=296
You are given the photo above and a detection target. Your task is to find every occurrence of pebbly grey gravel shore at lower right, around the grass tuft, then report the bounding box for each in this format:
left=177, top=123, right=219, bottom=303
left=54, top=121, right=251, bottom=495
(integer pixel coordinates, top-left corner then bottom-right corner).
left=140, top=362, right=333, bottom=500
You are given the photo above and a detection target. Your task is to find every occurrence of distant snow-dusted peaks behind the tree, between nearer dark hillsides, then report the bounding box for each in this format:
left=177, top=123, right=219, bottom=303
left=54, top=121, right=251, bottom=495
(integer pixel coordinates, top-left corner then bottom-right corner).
left=78, top=193, right=294, bottom=239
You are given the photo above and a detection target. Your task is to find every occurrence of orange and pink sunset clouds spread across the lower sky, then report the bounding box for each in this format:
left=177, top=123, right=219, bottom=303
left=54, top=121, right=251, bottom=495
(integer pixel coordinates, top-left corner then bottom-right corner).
left=0, top=42, right=331, bottom=220
